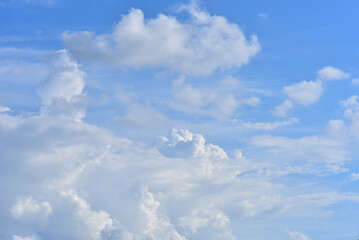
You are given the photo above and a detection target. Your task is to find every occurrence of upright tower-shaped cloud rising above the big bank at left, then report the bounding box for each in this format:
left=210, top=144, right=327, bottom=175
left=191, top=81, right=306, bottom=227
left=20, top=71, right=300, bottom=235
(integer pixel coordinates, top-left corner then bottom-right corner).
left=38, top=50, right=86, bottom=121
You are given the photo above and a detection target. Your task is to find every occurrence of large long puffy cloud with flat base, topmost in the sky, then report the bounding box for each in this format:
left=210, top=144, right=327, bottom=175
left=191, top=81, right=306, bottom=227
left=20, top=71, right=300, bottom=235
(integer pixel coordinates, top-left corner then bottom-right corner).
left=63, top=4, right=260, bottom=76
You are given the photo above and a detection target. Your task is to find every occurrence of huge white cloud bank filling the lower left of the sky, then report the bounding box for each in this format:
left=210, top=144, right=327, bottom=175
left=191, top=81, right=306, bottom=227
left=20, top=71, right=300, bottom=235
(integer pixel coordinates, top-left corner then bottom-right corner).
left=0, top=108, right=359, bottom=240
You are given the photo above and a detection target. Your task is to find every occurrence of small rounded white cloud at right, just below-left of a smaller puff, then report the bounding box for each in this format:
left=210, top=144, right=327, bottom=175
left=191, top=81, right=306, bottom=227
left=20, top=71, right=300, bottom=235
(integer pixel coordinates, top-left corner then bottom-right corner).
left=283, top=81, right=323, bottom=106
